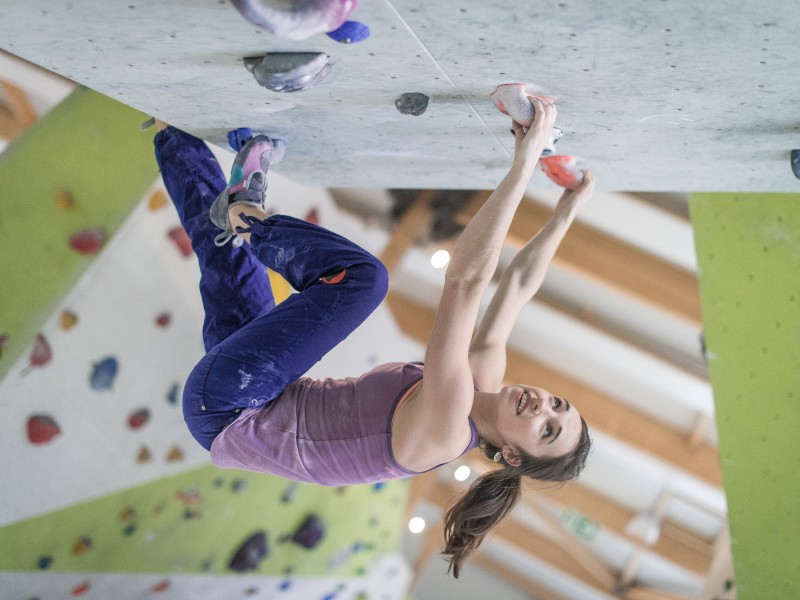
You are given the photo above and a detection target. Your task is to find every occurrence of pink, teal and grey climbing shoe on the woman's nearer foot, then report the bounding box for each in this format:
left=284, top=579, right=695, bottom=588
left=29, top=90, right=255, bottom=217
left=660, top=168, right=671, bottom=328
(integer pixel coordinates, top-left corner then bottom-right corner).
left=209, top=135, right=286, bottom=246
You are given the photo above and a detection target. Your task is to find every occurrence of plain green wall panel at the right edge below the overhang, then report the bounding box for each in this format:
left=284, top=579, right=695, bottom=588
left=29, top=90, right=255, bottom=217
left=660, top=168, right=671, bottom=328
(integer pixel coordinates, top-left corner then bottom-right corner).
left=690, top=194, right=800, bottom=600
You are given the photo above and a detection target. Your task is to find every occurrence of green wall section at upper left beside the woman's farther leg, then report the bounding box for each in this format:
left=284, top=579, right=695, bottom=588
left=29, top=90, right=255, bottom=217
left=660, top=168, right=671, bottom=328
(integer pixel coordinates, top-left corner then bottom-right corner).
left=0, top=88, right=158, bottom=377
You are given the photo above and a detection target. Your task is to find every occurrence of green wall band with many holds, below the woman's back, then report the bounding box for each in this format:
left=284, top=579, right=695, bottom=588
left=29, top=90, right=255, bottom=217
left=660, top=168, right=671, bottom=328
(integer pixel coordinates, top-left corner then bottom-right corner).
left=0, top=466, right=407, bottom=577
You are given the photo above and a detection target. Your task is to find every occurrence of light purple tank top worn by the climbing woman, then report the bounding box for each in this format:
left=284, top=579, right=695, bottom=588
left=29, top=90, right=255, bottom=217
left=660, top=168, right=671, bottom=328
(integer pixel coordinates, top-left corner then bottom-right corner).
left=211, top=363, right=478, bottom=485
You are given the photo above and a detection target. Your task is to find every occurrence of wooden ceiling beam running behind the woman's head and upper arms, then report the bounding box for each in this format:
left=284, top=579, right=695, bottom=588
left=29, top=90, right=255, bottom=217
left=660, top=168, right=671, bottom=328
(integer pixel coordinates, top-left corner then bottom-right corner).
left=387, top=291, right=722, bottom=487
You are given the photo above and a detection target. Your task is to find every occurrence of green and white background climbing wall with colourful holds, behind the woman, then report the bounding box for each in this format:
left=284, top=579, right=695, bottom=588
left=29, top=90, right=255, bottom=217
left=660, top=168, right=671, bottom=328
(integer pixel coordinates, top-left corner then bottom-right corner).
left=0, top=90, right=420, bottom=599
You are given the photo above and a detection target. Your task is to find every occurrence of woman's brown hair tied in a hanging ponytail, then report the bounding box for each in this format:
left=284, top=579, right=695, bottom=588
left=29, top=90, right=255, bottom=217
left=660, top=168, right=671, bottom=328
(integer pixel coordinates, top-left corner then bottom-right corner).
left=442, top=417, right=592, bottom=578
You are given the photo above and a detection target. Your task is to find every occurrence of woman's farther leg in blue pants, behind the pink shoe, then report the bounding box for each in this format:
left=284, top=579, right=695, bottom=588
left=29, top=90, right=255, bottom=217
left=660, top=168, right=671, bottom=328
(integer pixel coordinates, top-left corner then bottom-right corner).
left=154, top=127, right=275, bottom=351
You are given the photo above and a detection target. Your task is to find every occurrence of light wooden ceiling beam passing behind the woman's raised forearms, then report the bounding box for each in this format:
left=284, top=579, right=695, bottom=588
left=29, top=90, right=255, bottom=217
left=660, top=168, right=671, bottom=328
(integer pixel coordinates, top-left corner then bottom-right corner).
left=460, top=192, right=702, bottom=326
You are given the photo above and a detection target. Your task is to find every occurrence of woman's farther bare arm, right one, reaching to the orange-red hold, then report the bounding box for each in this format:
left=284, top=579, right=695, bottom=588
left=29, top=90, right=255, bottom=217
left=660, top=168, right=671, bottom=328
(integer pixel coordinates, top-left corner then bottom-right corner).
left=469, top=171, right=595, bottom=392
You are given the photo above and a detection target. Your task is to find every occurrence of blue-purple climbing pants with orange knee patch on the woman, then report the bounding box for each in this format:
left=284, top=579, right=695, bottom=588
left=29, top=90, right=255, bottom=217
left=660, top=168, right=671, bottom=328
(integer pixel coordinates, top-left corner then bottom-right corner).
left=154, top=127, right=388, bottom=449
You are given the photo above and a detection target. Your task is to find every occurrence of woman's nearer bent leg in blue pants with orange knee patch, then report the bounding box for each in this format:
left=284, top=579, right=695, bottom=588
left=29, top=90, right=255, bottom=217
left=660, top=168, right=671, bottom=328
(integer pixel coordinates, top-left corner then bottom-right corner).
left=184, top=213, right=388, bottom=448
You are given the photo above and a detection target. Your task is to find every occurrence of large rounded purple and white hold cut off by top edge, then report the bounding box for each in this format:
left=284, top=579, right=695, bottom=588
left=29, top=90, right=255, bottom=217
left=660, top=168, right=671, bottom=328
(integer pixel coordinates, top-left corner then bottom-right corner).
left=231, top=0, right=357, bottom=40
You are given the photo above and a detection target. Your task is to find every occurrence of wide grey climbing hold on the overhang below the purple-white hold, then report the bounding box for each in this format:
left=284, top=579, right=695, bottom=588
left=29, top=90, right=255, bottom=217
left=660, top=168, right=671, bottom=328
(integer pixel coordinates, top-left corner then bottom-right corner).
left=244, top=52, right=332, bottom=92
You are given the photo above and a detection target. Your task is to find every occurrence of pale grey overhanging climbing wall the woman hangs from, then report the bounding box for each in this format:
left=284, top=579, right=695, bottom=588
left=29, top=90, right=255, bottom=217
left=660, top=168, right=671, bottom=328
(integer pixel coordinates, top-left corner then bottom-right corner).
left=0, top=0, right=800, bottom=191
